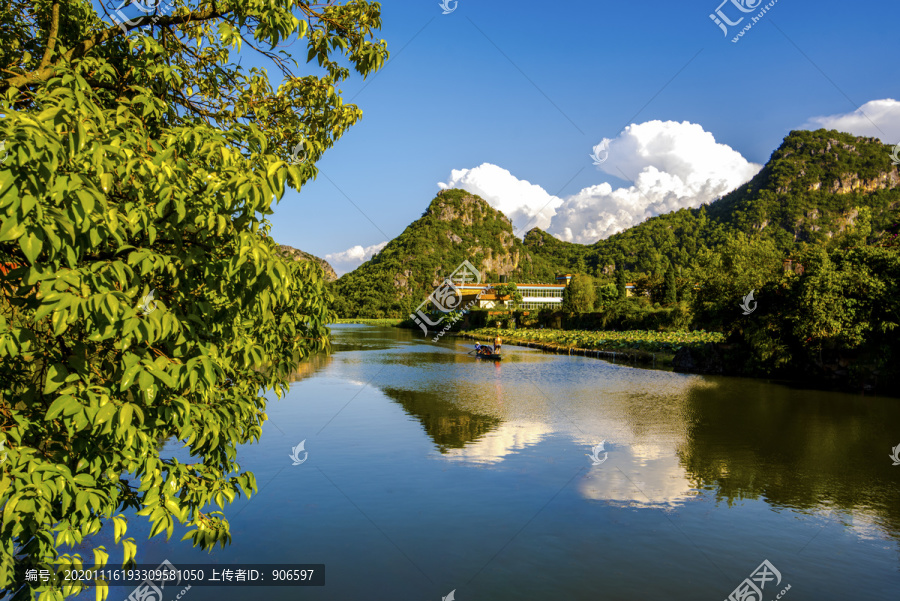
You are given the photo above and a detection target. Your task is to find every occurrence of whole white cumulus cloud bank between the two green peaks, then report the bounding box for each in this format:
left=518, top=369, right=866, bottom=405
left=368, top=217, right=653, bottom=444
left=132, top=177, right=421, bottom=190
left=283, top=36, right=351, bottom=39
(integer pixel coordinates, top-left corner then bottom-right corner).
left=438, top=121, right=762, bottom=244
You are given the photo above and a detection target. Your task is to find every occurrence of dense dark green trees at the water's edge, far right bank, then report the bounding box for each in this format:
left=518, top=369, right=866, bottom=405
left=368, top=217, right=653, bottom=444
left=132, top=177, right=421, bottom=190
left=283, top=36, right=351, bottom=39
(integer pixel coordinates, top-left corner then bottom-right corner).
left=708, top=245, right=900, bottom=382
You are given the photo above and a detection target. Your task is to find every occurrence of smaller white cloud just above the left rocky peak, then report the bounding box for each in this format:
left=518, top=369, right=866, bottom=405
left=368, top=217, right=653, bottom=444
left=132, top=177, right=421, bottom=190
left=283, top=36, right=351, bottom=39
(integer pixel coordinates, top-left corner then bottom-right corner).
left=438, top=163, right=562, bottom=236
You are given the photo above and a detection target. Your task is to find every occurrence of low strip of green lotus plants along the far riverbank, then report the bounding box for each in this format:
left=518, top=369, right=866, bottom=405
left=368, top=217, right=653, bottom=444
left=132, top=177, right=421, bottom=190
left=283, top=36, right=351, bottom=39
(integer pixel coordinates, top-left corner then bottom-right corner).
left=468, top=328, right=723, bottom=354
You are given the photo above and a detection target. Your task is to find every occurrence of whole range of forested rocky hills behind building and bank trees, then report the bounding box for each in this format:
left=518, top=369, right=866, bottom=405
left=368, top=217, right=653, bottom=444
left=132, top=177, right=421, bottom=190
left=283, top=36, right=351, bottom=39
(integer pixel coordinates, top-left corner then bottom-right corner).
left=334, top=130, right=900, bottom=317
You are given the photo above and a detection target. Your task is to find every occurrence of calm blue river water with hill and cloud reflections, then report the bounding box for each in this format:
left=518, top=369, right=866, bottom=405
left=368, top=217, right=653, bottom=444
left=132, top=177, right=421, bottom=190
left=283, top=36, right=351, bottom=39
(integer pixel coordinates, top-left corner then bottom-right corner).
left=102, top=325, right=900, bottom=601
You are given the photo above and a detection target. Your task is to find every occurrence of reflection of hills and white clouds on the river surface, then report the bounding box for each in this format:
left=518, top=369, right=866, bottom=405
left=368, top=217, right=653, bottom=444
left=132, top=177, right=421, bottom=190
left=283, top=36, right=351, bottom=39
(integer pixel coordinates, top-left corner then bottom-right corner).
left=336, top=329, right=900, bottom=538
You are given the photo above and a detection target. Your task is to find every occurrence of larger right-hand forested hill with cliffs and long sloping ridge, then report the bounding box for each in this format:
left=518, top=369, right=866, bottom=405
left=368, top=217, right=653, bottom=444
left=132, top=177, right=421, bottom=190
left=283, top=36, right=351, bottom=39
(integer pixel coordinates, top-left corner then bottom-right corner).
left=525, top=129, right=900, bottom=277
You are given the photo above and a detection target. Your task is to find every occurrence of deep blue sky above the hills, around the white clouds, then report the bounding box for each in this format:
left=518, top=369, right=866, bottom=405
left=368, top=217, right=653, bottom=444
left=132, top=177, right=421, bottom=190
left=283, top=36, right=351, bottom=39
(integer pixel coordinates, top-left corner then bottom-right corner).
left=137, top=0, right=900, bottom=272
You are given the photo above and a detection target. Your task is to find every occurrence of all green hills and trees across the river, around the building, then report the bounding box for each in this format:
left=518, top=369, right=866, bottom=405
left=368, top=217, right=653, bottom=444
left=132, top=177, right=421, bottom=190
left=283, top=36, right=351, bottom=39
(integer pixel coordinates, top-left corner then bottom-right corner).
left=328, top=130, right=900, bottom=392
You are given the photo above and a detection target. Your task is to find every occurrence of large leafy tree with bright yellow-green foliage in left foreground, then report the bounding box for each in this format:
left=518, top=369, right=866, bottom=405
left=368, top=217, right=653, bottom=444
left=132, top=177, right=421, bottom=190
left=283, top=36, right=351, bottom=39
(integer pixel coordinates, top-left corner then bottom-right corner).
left=0, top=0, right=387, bottom=599
